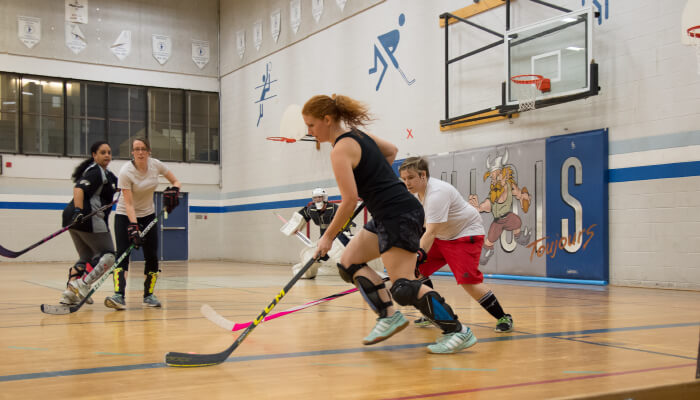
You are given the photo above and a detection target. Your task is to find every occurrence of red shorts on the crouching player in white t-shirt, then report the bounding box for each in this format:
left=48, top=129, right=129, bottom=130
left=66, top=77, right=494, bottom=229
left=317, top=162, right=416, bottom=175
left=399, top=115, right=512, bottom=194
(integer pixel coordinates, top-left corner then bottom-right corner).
left=418, top=236, right=484, bottom=285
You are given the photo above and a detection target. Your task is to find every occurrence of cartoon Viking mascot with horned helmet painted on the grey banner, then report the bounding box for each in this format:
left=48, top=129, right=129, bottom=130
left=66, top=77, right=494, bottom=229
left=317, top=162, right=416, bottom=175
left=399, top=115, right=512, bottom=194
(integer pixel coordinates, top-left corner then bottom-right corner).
left=469, top=149, right=532, bottom=265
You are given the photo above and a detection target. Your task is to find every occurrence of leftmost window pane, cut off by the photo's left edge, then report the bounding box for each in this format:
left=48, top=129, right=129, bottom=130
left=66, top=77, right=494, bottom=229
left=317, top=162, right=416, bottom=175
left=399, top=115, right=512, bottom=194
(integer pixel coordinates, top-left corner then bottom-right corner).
left=0, top=74, right=19, bottom=153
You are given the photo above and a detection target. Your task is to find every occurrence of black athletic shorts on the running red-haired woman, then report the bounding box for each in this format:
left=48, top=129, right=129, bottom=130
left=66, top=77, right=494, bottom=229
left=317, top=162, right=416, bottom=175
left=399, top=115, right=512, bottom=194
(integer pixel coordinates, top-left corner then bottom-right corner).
left=365, top=207, right=425, bottom=253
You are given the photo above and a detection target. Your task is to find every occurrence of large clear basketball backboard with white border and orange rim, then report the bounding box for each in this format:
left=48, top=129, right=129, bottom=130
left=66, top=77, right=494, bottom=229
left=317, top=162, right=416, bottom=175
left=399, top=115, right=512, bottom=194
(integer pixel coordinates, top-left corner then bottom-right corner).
left=504, top=7, right=593, bottom=106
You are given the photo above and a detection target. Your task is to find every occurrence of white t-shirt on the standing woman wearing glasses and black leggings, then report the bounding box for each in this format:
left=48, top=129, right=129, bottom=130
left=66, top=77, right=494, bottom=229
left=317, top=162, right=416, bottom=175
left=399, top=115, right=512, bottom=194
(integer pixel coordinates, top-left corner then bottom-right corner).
left=115, top=157, right=169, bottom=218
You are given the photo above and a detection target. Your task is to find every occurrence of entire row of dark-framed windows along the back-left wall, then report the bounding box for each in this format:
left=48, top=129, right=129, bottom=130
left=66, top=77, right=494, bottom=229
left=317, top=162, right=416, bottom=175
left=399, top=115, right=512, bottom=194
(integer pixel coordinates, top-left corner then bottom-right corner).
left=0, top=72, right=220, bottom=163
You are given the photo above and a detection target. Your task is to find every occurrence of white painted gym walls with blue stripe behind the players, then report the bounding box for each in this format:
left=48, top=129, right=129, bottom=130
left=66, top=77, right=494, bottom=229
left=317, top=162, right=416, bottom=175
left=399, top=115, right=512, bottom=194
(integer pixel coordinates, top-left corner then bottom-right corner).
left=0, top=0, right=700, bottom=290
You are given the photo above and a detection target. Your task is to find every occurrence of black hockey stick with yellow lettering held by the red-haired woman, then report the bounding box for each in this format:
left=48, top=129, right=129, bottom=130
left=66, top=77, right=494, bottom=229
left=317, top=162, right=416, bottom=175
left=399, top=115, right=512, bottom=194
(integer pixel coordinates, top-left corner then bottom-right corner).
left=165, top=202, right=365, bottom=367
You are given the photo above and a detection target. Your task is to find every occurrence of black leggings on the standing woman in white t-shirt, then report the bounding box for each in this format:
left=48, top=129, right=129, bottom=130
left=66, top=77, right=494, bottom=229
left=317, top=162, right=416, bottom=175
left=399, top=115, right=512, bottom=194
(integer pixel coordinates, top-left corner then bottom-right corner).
left=114, top=214, right=158, bottom=274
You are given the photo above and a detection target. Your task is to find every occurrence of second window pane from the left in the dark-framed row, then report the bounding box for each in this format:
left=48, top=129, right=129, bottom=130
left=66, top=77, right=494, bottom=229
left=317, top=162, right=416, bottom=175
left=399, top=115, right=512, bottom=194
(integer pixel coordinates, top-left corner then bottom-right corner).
left=22, top=77, right=65, bottom=155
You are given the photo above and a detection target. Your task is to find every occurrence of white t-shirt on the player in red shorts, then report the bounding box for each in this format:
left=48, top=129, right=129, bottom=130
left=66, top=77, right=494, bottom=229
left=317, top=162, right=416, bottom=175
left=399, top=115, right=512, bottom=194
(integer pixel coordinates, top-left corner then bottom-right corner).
left=423, top=178, right=485, bottom=240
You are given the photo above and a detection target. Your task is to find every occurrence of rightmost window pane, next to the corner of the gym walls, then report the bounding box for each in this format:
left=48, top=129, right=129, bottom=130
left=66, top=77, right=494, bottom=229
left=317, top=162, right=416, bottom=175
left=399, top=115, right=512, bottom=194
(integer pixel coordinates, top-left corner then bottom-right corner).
left=187, top=92, right=219, bottom=162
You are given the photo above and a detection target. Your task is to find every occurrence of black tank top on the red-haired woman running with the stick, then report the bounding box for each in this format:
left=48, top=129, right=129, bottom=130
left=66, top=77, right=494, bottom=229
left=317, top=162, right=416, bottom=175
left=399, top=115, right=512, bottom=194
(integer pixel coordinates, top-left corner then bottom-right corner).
left=335, top=129, right=422, bottom=219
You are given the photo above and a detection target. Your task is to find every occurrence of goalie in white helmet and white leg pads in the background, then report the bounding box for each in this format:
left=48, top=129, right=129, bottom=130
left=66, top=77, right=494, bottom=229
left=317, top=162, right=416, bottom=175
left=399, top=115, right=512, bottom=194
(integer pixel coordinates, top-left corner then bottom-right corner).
left=280, top=188, right=384, bottom=279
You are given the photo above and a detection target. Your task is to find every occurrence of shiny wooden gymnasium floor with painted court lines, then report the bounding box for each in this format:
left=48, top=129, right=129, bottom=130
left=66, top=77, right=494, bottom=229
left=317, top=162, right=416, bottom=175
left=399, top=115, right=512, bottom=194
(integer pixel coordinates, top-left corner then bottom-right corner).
left=0, top=262, right=700, bottom=400
